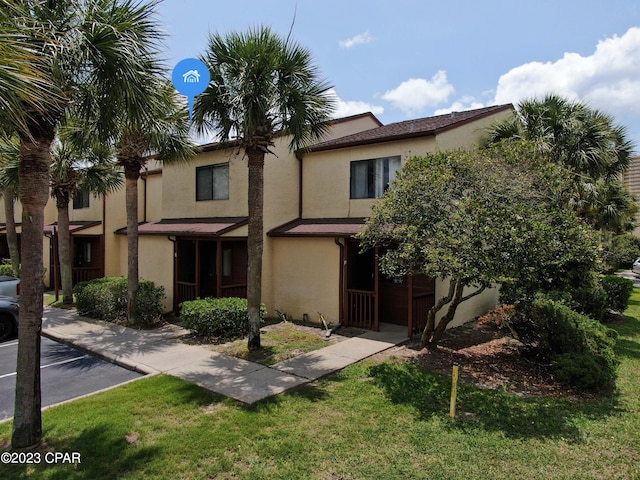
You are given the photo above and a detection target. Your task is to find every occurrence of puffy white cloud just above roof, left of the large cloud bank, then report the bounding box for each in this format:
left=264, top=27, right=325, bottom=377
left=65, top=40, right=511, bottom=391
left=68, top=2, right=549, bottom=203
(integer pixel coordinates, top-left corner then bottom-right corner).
left=382, top=70, right=455, bottom=115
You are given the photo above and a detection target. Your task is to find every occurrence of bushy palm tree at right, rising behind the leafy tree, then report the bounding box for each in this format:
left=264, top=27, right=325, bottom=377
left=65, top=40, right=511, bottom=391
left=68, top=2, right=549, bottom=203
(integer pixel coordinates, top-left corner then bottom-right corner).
left=487, top=95, right=634, bottom=230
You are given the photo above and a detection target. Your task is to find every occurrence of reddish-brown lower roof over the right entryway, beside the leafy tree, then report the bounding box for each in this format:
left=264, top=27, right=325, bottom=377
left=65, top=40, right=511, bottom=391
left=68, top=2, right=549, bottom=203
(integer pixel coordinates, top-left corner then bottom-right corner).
left=268, top=218, right=365, bottom=237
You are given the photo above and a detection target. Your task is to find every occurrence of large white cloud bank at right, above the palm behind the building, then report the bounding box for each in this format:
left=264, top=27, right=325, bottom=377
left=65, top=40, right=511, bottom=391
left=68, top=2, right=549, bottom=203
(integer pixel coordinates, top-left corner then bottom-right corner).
left=495, top=27, right=640, bottom=117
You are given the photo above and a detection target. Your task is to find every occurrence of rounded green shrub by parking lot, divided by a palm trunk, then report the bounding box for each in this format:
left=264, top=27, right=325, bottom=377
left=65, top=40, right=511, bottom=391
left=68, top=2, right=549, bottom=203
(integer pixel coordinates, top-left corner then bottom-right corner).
left=73, top=277, right=165, bottom=326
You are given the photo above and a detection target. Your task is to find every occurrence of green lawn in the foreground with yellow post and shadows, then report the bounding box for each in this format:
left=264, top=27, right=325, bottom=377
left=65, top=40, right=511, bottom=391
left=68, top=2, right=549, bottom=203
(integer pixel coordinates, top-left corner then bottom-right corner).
left=0, top=289, right=640, bottom=480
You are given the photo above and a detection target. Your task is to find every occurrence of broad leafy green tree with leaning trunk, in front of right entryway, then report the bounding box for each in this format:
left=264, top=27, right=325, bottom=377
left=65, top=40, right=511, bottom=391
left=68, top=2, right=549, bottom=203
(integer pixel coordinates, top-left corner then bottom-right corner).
left=358, top=142, right=597, bottom=347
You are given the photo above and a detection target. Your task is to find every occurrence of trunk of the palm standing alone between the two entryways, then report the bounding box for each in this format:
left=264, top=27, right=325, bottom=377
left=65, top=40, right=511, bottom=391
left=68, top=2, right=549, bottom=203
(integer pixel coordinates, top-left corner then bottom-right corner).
left=247, top=149, right=264, bottom=350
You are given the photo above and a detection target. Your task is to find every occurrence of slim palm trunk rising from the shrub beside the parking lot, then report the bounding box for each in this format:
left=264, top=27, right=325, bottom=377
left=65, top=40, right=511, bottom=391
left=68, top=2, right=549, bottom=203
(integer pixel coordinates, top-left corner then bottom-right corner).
left=124, top=162, right=140, bottom=325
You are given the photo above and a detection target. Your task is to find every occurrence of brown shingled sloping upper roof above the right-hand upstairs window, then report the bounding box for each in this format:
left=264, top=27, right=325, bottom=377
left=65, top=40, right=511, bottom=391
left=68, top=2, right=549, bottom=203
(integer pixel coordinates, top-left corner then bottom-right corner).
left=308, top=104, right=513, bottom=152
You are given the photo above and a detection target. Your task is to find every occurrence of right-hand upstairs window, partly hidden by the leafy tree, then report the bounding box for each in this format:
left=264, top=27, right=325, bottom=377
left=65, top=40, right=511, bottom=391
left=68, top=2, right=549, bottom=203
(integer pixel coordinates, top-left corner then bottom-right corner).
left=351, top=156, right=400, bottom=198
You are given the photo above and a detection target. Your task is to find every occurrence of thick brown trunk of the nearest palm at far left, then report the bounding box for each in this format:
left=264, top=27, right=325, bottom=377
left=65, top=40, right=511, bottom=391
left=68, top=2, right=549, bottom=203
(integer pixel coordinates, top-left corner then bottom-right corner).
left=11, top=126, right=54, bottom=448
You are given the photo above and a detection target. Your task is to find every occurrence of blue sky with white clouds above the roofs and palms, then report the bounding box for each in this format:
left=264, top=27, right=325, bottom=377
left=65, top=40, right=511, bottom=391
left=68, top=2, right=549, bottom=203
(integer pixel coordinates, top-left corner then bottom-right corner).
left=159, top=0, right=640, bottom=151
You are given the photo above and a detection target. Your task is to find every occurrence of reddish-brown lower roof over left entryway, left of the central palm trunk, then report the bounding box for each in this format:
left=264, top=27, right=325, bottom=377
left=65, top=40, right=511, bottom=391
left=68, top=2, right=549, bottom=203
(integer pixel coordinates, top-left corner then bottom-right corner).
left=115, top=217, right=247, bottom=236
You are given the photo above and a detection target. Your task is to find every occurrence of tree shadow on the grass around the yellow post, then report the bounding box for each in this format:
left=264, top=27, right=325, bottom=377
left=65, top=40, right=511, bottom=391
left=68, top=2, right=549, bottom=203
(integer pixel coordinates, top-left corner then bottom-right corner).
left=370, top=363, right=617, bottom=442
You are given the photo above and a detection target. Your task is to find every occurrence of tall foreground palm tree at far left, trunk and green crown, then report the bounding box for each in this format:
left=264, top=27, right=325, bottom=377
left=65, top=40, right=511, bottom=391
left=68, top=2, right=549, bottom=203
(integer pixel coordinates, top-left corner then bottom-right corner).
left=12, top=0, right=161, bottom=448
